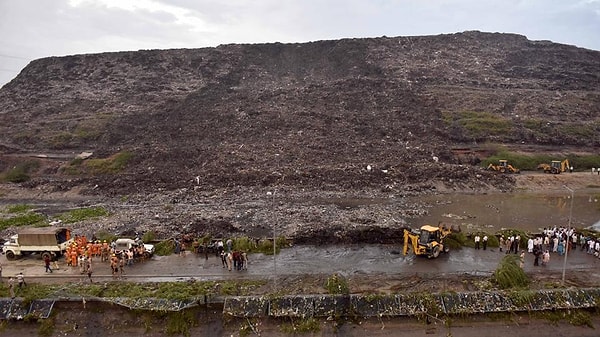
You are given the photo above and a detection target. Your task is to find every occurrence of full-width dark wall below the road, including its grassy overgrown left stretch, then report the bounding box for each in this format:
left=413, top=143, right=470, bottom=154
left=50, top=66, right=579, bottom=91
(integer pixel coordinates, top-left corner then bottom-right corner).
left=0, top=288, right=600, bottom=319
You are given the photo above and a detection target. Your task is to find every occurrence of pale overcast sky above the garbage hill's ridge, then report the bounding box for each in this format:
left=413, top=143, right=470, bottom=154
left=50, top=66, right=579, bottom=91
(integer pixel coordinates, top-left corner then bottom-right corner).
left=0, top=0, right=600, bottom=86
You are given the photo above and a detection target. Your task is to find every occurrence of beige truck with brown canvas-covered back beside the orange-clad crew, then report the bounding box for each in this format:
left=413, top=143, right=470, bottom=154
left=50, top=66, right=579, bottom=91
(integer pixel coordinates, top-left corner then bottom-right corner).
left=2, top=227, right=74, bottom=260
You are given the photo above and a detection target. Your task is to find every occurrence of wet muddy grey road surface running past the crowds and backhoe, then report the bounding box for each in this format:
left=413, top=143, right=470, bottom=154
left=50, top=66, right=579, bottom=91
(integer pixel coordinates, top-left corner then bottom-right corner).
left=0, top=245, right=600, bottom=282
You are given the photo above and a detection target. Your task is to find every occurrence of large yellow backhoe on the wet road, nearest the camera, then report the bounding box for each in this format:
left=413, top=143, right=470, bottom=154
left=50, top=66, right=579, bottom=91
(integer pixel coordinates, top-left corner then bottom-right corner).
left=402, top=225, right=452, bottom=259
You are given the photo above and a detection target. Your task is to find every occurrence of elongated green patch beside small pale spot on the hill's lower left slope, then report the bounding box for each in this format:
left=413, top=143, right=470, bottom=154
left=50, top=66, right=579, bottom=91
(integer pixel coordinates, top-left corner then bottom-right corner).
left=64, top=151, right=133, bottom=175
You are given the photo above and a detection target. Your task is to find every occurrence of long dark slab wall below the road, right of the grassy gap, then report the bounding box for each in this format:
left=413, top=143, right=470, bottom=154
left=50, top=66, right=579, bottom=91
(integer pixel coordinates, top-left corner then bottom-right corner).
left=223, top=288, right=600, bottom=317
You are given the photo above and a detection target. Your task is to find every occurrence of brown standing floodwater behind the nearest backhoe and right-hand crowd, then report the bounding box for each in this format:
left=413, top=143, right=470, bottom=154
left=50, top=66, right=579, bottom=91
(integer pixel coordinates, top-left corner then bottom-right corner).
left=411, top=190, right=600, bottom=233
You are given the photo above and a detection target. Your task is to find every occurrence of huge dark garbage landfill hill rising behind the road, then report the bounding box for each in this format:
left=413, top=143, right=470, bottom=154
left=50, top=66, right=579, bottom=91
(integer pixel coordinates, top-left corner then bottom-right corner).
left=0, top=31, right=600, bottom=195
